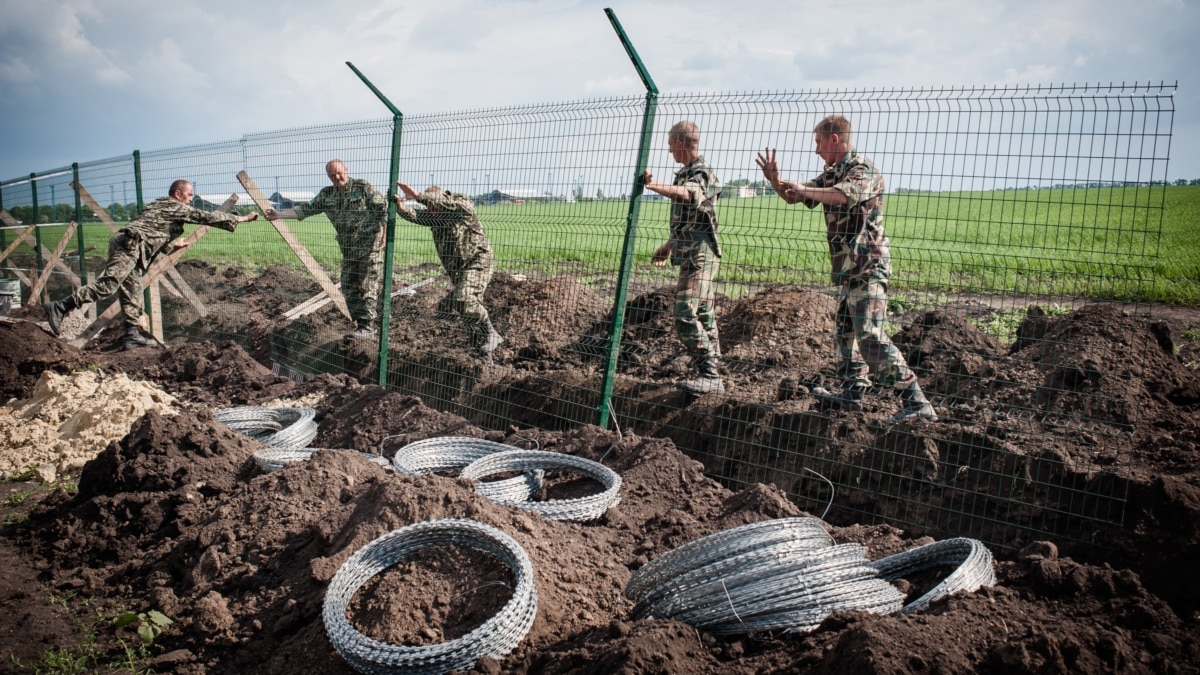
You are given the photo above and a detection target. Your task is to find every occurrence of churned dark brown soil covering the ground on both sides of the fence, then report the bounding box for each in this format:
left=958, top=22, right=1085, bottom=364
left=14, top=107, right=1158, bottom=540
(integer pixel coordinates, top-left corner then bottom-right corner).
left=0, top=260, right=1200, bottom=674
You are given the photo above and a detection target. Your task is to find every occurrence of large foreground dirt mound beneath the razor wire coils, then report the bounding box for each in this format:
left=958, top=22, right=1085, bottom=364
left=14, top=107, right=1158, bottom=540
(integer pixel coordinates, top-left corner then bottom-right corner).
left=7, top=369, right=1196, bottom=673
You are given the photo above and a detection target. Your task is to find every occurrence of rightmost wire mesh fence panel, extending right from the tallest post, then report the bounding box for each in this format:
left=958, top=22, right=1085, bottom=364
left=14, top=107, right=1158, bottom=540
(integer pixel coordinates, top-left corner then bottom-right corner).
left=600, top=85, right=1174, bottom=550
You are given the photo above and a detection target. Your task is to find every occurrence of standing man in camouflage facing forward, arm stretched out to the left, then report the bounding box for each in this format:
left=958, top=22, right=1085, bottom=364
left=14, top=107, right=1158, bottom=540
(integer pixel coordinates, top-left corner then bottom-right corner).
left=266, top=160, right=388, bottom=339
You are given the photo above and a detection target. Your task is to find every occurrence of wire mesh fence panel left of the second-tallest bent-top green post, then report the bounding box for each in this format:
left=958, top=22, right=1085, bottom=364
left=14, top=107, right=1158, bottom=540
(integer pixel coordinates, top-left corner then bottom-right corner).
left=142, top=120, right=391, bottom=377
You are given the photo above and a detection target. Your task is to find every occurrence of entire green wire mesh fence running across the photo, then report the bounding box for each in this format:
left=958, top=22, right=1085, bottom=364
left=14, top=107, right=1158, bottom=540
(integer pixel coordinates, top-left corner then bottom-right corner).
left=0, top=78, right=1174, bottom=545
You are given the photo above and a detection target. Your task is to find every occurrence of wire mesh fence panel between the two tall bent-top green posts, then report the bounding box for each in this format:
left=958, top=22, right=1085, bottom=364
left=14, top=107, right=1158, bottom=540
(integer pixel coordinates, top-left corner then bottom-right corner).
left=388, top=98, right=644, bottom=428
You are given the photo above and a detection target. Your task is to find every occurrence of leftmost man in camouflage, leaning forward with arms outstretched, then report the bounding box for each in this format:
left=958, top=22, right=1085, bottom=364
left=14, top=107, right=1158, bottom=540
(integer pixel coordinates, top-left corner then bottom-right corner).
left=46, top=180, right=258, bottom=350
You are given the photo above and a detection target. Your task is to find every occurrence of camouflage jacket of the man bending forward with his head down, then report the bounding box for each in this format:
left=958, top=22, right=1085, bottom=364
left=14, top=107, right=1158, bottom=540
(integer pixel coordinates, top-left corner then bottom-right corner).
left=396, top=191, right=492, bottom=271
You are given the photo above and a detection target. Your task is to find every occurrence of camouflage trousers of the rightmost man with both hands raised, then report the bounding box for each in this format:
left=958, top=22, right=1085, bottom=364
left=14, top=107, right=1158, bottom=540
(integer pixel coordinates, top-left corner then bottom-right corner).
left=835, top=279, right=917, bottom=389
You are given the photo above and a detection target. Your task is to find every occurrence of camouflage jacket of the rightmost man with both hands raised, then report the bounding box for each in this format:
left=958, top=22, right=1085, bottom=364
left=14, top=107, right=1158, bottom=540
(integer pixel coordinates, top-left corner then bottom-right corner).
left=804, top=149, right=892, bottom=286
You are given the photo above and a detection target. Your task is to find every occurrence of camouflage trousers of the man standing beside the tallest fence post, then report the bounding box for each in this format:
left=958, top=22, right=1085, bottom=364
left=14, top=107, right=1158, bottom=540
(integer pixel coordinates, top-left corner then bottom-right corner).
left=671, top=241, right=721, bottom=358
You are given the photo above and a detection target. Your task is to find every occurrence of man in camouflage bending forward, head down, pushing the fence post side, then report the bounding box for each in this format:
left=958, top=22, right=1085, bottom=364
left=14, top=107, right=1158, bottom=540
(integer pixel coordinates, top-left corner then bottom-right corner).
left=394, top=181, right=504, bottom=356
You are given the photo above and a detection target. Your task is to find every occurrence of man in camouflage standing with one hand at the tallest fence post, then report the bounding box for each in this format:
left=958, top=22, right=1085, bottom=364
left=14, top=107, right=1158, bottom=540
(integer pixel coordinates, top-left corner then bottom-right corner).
left=643, top=121, right=725, bottom=394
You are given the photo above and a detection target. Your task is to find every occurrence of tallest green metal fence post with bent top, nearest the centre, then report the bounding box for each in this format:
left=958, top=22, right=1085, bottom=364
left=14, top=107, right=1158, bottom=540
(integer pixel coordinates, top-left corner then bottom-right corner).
left=596, top=7, right=659, bottom=428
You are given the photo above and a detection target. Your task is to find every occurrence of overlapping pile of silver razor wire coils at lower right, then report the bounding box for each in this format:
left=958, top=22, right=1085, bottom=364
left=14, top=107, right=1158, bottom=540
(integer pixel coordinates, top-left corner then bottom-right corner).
left=625, top=518, right=995, bottom=634
